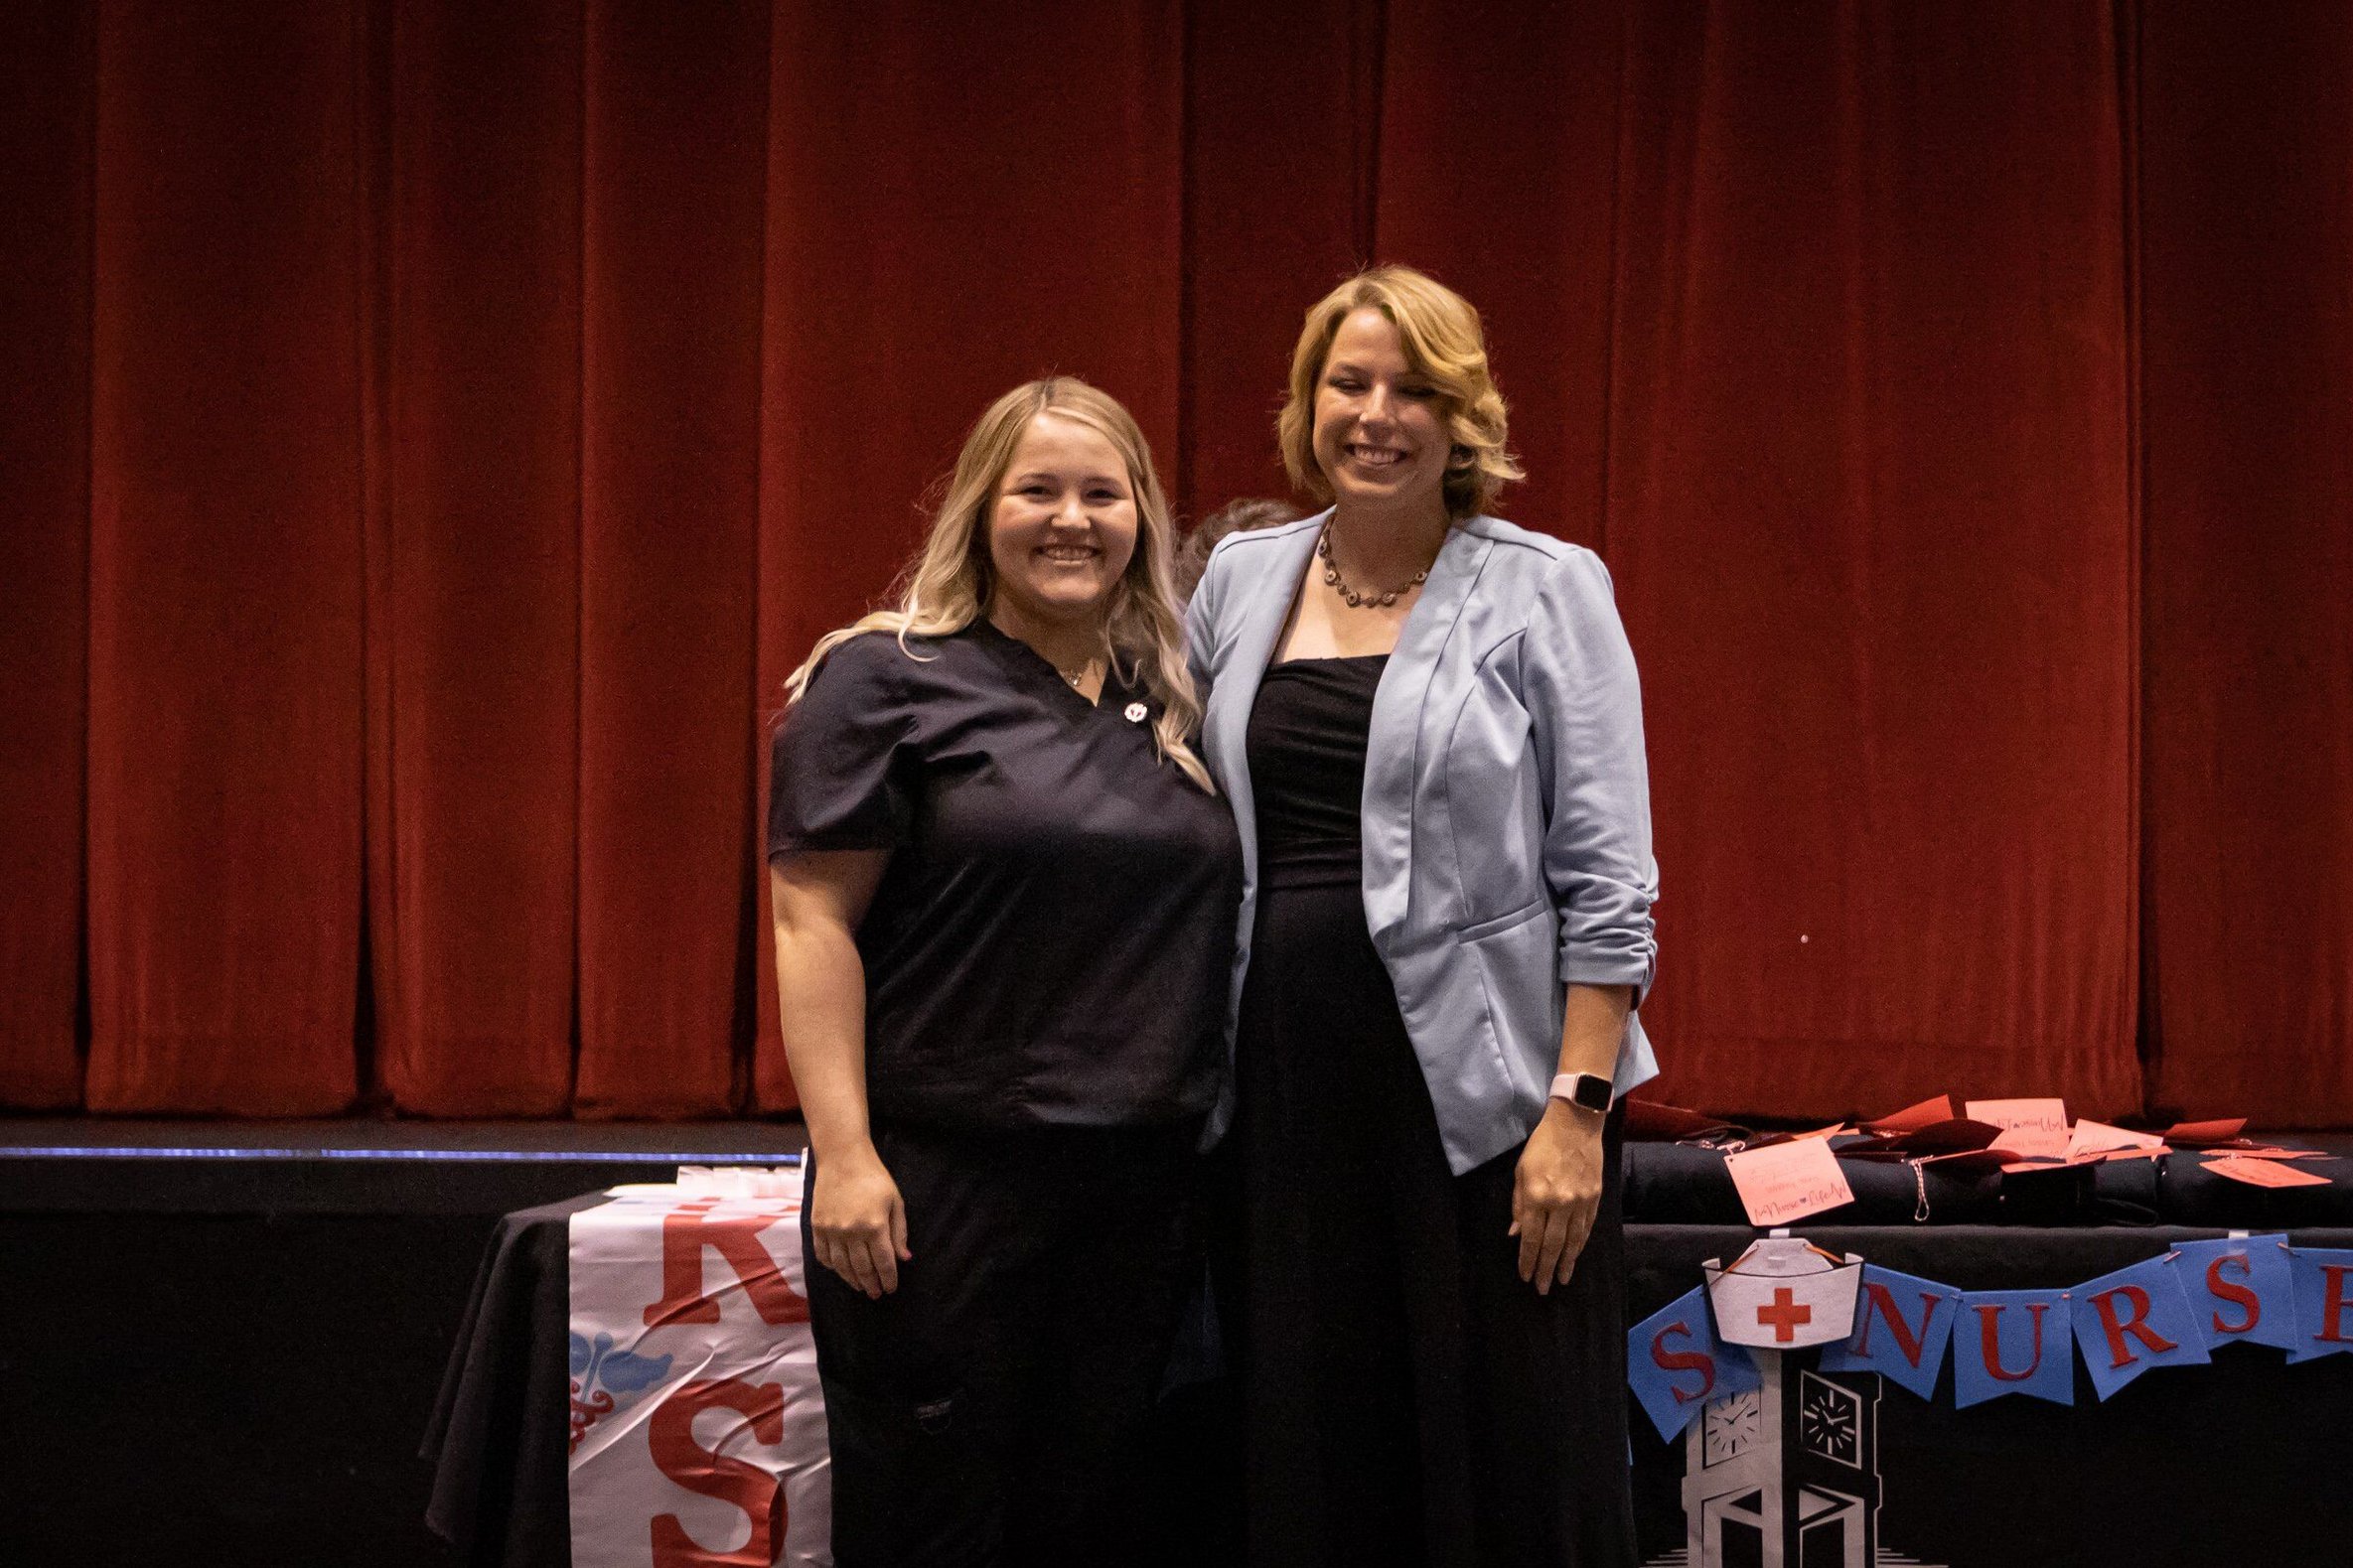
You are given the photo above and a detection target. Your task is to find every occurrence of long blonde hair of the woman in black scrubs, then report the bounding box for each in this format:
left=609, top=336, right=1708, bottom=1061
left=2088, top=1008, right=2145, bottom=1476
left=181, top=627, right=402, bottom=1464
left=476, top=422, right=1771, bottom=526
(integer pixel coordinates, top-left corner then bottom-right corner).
left=784, top=376, right=1217, bottom=794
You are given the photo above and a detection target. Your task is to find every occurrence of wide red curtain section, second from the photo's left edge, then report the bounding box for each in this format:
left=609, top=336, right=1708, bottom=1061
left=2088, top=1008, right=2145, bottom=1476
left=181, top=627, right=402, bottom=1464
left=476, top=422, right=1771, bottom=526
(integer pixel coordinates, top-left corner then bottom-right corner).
left=87, top=0, right=363, bottom=1114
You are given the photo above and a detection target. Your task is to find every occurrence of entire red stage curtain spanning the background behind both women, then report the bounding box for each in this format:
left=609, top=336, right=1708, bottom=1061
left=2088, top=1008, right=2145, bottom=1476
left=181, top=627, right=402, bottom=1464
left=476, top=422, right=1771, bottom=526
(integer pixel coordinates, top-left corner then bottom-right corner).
left=0, top=0, right=2353, bottom=1124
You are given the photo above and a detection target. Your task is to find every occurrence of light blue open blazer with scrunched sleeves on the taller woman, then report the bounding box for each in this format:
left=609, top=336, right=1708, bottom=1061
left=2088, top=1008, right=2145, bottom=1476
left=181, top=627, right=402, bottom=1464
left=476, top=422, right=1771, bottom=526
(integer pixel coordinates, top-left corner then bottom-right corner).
left=1186, top=512, right=1659, bottom=1173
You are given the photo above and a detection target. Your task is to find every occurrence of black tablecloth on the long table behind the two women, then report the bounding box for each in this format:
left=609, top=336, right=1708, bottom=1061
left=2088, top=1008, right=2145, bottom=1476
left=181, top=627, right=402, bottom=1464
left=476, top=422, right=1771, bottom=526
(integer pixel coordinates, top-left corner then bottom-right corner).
left=428, top=1145, right=2353, bottom=1568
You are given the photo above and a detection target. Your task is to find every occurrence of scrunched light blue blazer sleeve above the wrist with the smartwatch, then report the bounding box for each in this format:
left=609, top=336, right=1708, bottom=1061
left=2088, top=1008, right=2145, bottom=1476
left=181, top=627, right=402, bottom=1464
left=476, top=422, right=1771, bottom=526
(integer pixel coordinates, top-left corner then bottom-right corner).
left=1520, top=550, right=1659, bottom=1006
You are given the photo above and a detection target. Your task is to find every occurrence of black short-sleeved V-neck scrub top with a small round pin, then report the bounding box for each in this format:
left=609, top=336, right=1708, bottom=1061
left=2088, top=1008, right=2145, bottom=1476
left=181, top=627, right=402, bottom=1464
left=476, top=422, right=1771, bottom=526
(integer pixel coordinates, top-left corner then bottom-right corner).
left=767, top=621, right=1243, bottom=1128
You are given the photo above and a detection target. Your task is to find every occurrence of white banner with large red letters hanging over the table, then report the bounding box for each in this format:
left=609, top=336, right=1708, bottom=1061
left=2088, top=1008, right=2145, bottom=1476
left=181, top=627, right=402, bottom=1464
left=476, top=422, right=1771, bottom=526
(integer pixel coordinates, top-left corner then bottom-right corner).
left=569, top=1171, right=833, bottom=1568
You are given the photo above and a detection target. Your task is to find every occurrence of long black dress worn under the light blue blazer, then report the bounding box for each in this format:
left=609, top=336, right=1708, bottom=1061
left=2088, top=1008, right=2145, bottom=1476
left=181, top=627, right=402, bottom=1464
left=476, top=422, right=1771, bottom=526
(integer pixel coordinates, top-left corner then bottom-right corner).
left=1222, top=655, right=1633, bottom=1568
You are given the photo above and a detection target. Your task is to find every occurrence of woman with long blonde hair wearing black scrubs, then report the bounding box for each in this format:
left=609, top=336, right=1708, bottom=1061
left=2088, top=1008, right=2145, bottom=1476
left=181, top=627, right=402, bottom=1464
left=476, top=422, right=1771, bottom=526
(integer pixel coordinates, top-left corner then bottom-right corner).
left=770, top=378, right=1240, bottom=1568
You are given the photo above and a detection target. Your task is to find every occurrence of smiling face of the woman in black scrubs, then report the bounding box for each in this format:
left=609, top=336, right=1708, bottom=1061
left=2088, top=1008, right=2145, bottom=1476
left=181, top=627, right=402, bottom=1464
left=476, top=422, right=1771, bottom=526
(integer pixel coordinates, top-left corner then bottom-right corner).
left=988, top=409, right=1136, bottom=630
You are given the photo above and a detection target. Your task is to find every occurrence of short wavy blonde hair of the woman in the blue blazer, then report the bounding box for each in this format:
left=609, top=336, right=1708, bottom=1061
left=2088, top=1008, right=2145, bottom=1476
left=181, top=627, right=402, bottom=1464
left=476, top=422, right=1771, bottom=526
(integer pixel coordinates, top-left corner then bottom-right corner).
left=1275, top=266, right=1523, bottom=522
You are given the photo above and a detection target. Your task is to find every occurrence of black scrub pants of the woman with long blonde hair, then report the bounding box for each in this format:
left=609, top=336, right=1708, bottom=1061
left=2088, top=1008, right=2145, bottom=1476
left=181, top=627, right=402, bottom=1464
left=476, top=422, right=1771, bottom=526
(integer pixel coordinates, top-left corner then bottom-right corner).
left=803, top=1126, right=1200, bottom=1568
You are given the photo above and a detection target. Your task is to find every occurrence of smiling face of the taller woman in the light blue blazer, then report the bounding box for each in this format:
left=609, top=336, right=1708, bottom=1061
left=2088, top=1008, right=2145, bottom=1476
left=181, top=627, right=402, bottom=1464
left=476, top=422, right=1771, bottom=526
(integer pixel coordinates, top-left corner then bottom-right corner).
left=1315, top=306, right=1454, bottom=512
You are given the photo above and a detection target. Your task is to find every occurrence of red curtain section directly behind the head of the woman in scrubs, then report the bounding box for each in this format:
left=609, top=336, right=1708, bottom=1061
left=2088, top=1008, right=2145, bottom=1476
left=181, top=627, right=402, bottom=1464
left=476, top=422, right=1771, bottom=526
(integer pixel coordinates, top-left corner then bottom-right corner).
left=758, top=0, right=1184, bottom=1107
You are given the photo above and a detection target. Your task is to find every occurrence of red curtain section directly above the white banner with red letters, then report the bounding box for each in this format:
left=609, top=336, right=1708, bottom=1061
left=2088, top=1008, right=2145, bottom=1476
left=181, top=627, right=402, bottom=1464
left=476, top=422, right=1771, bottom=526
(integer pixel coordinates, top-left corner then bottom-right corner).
left=574, top=0, right=767, bottom=1116
